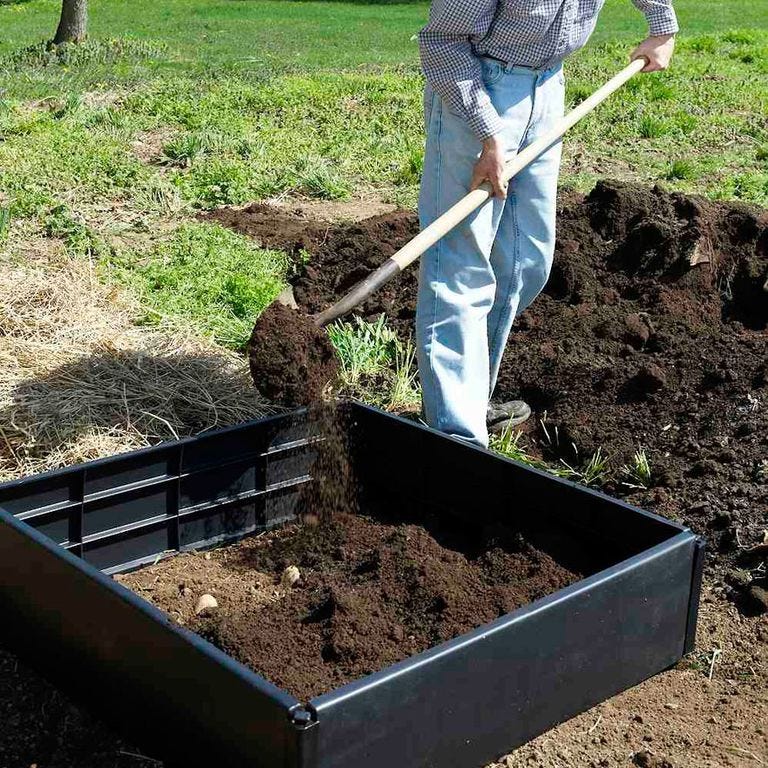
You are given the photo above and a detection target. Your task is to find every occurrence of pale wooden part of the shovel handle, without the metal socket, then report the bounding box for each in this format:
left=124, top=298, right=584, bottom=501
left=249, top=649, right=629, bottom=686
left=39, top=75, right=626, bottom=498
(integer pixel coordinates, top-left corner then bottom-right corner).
left=390, top=58, right=648, bottom=272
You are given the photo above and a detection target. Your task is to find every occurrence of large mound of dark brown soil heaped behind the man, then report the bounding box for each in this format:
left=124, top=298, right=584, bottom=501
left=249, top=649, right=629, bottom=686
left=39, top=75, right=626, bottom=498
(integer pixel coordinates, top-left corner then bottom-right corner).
left=208, top=182, right=768, bottom=599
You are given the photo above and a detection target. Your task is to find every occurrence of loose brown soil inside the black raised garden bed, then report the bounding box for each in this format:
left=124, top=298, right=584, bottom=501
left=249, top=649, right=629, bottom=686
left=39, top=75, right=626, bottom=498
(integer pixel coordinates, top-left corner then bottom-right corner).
left=117, top=509, right=584, bottom=700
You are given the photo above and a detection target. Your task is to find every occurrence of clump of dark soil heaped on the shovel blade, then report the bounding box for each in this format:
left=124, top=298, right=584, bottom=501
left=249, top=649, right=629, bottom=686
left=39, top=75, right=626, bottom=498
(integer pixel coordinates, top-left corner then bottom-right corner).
left=248, top=302, right=338, bottom=408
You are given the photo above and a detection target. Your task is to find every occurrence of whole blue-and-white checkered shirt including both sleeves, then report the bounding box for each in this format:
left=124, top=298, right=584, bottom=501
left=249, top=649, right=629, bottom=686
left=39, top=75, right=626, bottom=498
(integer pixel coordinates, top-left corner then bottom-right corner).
left=419, top=0, right=678, bottom=140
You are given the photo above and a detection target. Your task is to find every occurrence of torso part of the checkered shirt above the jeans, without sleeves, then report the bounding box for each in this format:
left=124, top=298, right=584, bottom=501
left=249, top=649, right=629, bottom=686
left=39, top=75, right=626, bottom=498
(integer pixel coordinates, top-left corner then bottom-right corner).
left=473, top=0, right=605, bottom=67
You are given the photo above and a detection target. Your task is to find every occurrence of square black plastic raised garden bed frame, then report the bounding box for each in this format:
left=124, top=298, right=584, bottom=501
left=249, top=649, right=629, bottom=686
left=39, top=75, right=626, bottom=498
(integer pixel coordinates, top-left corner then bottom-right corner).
left=0, top=404, right=703, bottom=768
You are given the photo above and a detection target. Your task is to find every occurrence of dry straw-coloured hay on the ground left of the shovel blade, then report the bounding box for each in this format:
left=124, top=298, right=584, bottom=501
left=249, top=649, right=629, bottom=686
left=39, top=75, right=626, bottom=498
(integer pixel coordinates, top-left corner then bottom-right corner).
left=0, top=259, right=270, bottom=480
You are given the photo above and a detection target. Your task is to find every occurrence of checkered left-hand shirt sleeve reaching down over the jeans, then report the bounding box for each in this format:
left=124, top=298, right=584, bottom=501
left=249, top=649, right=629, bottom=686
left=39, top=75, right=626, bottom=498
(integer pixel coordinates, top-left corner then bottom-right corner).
left=419, top=0, right=502, bottom=141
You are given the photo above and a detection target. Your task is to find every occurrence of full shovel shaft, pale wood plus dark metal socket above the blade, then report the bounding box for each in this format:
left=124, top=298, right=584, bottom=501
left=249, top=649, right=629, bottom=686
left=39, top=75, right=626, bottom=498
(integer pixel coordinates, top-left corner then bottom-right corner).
left=314, top=57, right=648, bottom=327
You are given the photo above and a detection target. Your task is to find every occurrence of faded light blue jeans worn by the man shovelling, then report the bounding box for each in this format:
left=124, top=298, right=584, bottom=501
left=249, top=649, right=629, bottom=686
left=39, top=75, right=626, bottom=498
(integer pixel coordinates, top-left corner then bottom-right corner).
left=416, top=58, right=564, bottom=446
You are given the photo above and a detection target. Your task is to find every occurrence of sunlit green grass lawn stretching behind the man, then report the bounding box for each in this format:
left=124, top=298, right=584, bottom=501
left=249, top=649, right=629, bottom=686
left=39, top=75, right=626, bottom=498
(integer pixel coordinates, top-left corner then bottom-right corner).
left=0, top=0, right=768, bottom=347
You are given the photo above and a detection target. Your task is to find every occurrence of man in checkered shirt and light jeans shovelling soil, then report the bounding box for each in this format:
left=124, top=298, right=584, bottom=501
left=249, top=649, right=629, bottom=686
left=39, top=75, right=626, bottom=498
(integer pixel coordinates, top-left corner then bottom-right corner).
left=416, top=0, right=678, bottom=446
